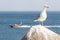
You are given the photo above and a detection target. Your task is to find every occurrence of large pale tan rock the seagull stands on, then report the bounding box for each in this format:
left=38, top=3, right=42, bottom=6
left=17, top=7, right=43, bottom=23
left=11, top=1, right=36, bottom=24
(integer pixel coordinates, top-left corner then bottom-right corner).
left=21, top=25, right=60, bottom=40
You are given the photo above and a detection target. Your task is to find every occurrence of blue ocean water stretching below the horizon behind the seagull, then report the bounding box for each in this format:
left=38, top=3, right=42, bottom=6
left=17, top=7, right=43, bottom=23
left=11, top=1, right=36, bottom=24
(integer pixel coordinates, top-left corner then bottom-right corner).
left=0, top=11, right=60, bottom=40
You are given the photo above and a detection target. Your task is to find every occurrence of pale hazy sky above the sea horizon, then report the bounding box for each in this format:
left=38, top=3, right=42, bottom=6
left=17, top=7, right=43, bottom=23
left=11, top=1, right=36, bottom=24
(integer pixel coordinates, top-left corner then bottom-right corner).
left=0, top=0, right=60, bottom=11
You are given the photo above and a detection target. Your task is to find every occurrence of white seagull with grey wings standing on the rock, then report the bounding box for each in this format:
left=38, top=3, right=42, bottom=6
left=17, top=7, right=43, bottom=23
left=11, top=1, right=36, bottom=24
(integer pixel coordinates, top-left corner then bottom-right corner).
left=34, top=4, right=49, bottom=25
